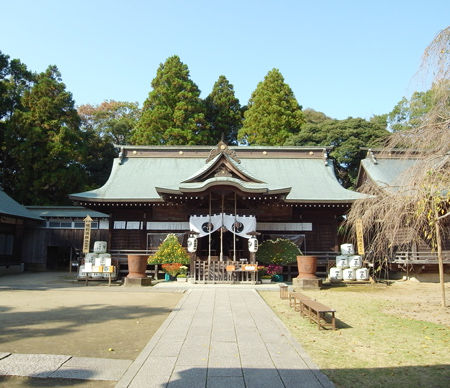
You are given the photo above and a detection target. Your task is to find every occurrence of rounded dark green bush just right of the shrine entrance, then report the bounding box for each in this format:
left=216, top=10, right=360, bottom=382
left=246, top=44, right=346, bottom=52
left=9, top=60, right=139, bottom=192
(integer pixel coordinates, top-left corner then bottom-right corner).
left=256, top=238, right=302, bottom=265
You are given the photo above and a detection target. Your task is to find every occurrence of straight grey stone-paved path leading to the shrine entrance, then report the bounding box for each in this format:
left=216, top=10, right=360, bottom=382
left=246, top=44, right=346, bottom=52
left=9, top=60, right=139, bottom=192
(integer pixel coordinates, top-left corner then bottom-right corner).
left=117, top=288, right=333, bottom=388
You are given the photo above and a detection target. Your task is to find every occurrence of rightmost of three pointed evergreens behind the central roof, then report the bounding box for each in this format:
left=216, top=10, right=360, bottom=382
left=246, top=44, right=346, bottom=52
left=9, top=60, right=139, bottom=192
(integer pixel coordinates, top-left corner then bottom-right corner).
left=238, top=69, right=304, bottom=145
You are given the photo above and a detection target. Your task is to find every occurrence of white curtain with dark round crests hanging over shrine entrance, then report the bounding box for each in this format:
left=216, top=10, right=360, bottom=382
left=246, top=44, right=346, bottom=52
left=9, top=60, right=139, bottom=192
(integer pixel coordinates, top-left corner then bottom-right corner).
left=189, top=213, right=256, bottom=238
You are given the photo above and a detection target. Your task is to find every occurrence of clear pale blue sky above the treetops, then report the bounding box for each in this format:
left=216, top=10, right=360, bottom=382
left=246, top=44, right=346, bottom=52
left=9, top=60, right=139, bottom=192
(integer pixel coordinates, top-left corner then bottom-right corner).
left=0, top=0, right=450, bottom=119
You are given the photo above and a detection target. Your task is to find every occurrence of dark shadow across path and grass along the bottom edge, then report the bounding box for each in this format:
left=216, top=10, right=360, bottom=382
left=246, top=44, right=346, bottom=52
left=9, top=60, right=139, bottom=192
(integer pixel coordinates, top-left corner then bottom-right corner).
left=130, top=365, right=450, bottom=388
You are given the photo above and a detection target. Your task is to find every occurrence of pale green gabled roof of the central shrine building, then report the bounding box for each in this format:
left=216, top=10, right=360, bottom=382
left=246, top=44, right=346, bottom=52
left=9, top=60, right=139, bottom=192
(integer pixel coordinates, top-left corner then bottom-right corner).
left=70, top=144, right=363, bottom=203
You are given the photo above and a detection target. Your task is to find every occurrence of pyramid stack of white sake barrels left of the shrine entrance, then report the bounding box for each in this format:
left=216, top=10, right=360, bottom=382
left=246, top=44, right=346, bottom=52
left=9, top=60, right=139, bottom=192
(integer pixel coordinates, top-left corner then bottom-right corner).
left=78, top=241, right=116, bottom=280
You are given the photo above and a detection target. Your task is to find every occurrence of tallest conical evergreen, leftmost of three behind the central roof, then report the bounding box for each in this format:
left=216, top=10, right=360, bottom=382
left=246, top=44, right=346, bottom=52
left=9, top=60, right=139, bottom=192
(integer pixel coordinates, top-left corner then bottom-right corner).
left=132, top=55, right=211, bottom=145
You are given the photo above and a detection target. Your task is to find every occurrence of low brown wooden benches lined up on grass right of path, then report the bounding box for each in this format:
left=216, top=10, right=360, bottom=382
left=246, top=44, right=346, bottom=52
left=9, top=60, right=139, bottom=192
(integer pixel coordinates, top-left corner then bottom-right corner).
left=289, top=292, right=336, bottom=330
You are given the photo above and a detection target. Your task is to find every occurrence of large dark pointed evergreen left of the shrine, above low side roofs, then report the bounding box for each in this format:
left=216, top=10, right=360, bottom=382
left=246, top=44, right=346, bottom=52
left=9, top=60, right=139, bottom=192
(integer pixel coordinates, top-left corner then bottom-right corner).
left=5, top=66, right=86, bottom=204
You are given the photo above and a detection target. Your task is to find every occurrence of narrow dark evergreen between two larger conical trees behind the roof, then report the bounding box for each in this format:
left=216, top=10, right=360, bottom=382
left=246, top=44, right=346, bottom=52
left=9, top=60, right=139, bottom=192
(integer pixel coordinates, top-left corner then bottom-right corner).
left=205, top=75, right=242, bottom=144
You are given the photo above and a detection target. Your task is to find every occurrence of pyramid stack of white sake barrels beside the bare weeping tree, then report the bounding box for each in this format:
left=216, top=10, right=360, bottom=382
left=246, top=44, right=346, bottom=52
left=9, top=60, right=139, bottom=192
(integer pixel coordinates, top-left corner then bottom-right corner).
left=329, top=244, right=369, bottom=282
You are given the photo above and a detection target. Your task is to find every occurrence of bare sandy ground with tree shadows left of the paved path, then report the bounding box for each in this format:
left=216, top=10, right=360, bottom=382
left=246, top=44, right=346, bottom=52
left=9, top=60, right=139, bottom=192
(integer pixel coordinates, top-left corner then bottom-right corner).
left=0, top=274, right=182, bottom=360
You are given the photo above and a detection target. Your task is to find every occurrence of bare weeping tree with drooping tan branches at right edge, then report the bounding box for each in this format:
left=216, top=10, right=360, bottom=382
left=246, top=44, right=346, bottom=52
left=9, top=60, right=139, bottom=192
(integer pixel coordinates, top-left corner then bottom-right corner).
left=347, top=27, right=450, bottom=306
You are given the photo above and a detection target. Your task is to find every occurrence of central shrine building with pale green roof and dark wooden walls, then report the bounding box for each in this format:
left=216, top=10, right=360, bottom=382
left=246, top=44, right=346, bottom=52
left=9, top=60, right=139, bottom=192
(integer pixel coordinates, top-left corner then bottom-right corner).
left=70, top=142, right=362, bottom=280
